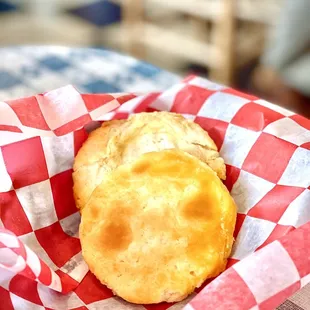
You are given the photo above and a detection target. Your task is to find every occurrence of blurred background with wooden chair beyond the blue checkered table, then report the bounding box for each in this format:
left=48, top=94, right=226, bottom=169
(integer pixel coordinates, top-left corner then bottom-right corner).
left=0, top=0, right=310, bottom=116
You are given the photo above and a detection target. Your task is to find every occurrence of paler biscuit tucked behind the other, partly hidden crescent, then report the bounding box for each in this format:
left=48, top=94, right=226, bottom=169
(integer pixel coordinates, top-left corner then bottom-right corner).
left=73, top=112, right=226, bottom=208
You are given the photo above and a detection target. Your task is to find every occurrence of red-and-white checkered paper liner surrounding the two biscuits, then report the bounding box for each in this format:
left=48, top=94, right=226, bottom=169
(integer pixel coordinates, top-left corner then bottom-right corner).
left=0, top=77, right=310, bottom=310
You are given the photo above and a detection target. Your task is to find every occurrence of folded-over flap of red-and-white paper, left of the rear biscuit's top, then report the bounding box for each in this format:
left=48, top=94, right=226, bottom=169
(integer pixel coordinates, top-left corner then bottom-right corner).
left=0, top=85, right=130, bottom=137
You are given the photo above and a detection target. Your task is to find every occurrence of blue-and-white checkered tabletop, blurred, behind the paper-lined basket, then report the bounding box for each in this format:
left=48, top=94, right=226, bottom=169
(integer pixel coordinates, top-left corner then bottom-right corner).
left=0, top=46, right=181, bottom=101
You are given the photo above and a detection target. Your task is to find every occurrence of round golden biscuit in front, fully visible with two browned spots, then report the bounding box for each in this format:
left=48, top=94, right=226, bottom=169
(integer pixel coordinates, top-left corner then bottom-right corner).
left=80, top=150, right=236, bottom=304
